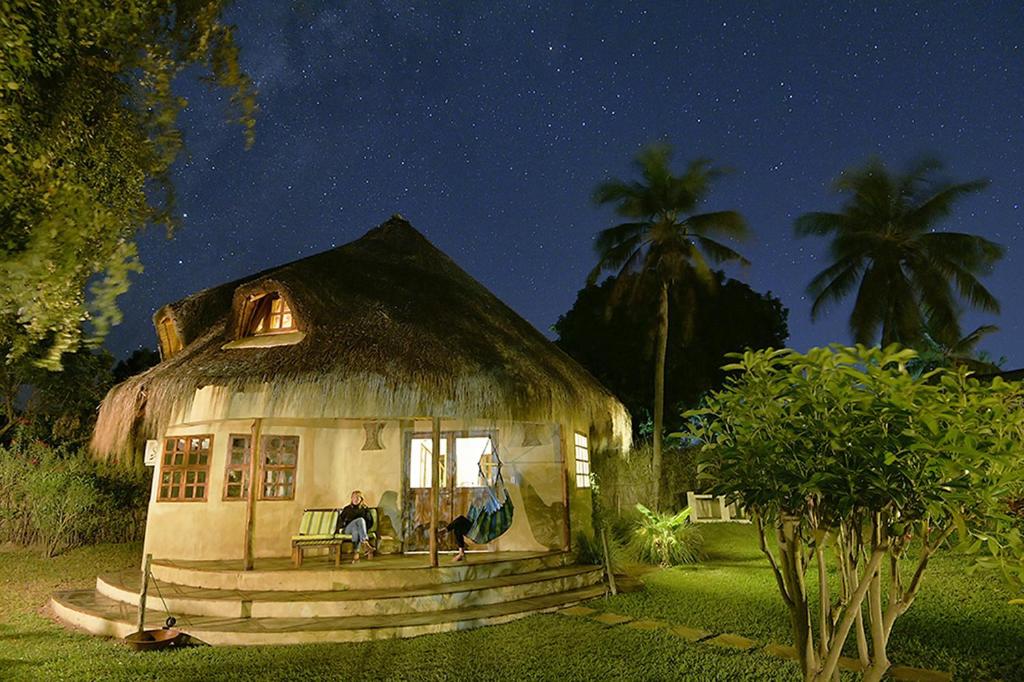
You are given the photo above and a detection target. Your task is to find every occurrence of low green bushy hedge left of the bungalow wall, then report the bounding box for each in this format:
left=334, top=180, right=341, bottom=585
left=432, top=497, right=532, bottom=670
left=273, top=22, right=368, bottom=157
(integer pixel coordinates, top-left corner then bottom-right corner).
left=0, top=440, right=150, bottom=556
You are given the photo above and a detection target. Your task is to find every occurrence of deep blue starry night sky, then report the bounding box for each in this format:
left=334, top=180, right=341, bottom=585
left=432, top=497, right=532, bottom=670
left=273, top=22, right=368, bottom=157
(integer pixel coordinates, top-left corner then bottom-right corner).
left=108, top=0, right=1024, bottom=369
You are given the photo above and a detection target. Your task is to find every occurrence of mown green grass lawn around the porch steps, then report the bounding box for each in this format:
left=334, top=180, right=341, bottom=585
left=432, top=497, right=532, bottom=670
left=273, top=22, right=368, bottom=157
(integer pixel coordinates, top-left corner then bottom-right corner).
left=0, top=525, right=1024, bottom=682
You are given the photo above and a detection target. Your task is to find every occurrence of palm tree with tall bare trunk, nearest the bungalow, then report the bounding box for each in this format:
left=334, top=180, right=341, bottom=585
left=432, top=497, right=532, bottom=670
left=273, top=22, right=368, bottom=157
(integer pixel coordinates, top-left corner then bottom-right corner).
left=588, top=144, right=748, bottom=508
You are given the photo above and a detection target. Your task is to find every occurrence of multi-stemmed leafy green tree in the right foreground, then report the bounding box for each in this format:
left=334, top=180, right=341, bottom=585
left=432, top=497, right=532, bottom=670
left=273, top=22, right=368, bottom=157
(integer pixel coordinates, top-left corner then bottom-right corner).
left=686, top=345, right=1024, bottom=681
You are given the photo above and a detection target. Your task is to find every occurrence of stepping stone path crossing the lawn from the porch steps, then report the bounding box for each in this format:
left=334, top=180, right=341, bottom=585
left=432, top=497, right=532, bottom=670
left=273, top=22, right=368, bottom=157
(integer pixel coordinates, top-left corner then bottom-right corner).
left=558, top=606, right=953, bottom=682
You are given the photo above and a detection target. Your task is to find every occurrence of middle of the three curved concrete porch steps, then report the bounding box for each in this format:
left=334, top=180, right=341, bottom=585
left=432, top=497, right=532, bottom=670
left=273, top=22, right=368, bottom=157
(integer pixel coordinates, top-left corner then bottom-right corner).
left=96, top=565, right=601, bottom=617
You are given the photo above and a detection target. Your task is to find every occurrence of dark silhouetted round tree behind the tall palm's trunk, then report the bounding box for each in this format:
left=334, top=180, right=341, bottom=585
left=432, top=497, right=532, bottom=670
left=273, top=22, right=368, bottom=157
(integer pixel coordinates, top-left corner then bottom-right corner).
left=553, top=270, right=790, bottom=430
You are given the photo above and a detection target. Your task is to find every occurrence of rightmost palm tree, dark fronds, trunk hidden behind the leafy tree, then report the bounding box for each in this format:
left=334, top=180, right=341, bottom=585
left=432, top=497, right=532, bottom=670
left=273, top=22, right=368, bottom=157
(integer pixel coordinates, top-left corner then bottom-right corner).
left=796, top=159, right=1004, bottom=346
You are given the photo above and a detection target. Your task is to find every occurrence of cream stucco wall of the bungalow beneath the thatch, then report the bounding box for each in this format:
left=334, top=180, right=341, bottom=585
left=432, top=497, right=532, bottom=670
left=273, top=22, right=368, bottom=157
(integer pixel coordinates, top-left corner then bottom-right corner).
left=145, top=411, right=590, bottom=559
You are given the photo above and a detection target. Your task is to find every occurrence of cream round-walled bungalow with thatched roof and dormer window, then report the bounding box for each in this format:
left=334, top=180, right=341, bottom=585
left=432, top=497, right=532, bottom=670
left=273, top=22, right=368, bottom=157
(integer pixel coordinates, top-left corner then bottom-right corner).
left=92, top=216, right=630, bottom=559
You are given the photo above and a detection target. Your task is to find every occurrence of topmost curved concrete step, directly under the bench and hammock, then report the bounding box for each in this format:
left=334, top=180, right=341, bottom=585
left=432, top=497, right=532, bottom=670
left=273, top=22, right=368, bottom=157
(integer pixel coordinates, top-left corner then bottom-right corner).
left=152, top=551, right=572, bottom=592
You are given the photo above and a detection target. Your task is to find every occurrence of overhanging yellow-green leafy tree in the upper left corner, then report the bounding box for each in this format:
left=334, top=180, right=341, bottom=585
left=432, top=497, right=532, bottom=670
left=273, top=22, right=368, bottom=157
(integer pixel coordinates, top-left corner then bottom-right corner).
left=0, top=0, right=256, bottom=369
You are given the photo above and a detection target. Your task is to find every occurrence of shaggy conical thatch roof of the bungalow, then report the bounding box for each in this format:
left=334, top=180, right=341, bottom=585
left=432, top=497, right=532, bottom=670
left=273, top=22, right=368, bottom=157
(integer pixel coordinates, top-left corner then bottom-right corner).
left=92, top=216, right=630, bottom=458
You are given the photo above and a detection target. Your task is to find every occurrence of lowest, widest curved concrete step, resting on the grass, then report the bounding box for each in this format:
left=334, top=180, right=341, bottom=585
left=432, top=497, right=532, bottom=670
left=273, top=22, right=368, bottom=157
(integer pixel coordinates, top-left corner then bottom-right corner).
left=50, top=585, right=604, bottom=645
